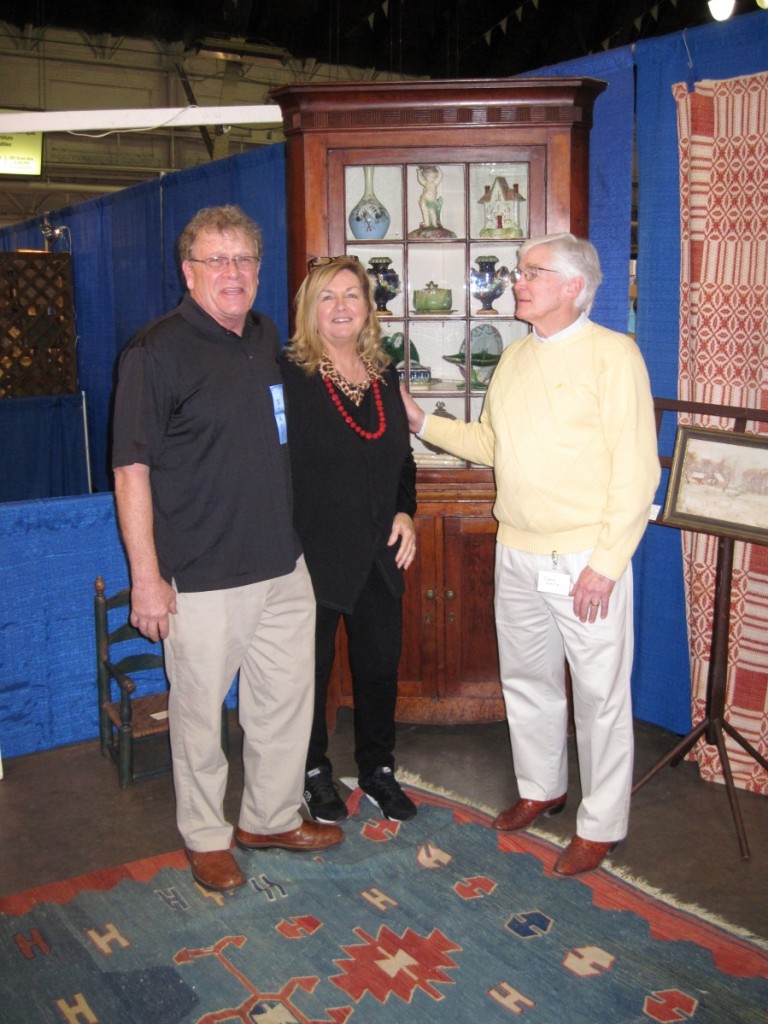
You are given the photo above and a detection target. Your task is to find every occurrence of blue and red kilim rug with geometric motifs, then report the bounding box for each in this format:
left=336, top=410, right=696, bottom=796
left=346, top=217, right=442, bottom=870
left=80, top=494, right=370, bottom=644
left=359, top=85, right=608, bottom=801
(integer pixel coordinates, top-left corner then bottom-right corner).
left=0, top=785, right=768, bottom=1024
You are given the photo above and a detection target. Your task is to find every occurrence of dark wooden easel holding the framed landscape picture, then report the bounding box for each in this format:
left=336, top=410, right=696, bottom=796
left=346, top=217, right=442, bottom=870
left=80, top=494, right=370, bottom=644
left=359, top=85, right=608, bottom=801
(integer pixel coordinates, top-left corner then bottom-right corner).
left=632, top=398, right=768, bottom=860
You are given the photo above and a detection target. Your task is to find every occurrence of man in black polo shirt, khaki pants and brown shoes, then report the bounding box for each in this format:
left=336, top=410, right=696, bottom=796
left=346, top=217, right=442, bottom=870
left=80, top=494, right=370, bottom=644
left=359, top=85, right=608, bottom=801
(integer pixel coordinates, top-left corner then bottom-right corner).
left=113, top=206, right=343, bottom=891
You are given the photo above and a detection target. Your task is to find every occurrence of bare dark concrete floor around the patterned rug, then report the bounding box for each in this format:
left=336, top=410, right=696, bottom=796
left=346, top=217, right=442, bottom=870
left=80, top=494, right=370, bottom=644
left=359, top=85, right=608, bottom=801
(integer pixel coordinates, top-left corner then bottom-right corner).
left=0, top=710, right=768, bottom=939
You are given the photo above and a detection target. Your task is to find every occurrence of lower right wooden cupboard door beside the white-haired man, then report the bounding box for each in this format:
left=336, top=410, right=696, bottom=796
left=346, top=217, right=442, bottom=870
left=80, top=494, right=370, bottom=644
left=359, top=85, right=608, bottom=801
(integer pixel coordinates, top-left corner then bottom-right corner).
left=441, top=516, right=501, bottom=698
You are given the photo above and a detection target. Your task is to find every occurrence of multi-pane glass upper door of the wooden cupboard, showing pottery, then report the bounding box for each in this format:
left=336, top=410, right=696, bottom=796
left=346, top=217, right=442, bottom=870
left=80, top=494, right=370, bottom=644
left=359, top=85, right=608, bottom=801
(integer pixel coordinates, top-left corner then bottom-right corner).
left=331, top=147, right=544, bottom=466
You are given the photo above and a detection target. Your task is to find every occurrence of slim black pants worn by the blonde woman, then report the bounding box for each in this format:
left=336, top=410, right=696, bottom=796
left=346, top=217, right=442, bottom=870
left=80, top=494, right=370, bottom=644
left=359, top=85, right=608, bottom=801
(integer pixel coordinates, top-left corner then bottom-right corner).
left=306, top=565, right=402, bottom=775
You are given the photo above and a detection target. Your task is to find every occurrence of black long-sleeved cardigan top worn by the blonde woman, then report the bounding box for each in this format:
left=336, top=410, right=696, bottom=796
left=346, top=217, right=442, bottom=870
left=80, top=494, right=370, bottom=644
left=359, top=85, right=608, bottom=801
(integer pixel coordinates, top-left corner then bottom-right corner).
left=281, top=355, right=416, bottom=612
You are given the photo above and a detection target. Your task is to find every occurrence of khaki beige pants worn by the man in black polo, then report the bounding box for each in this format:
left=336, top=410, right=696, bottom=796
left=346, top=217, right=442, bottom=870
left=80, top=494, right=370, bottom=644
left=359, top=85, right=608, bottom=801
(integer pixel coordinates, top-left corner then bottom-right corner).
left=165, top=557, right=315, bottom=852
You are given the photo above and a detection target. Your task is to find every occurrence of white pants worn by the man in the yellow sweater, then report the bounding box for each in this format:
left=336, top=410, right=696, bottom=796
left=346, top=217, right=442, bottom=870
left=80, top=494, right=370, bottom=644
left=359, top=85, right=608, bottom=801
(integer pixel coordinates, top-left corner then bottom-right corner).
left=495, top=544, right=634, bottom=843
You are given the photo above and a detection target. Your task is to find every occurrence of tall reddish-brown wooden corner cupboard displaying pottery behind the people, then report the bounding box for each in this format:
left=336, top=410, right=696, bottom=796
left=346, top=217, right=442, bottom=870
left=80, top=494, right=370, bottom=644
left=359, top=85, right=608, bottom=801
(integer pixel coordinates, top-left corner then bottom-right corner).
left=271, top=78, right=605, bottom=724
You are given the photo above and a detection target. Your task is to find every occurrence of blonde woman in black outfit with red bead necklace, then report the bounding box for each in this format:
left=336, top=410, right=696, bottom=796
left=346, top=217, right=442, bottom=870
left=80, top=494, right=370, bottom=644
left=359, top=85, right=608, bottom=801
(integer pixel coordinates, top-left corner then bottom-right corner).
left=282, top=256, right=416, bottom=822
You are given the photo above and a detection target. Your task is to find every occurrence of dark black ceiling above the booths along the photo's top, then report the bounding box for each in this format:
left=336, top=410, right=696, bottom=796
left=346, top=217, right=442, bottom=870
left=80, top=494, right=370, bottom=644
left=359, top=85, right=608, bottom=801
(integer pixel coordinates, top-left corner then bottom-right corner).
left=0, top=0, right=757, bottom=78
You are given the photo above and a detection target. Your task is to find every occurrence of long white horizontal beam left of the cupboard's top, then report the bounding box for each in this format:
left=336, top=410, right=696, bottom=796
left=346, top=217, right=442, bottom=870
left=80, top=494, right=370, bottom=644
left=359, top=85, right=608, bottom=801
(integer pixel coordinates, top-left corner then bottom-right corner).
left=0, top=103, right=283, bottom=135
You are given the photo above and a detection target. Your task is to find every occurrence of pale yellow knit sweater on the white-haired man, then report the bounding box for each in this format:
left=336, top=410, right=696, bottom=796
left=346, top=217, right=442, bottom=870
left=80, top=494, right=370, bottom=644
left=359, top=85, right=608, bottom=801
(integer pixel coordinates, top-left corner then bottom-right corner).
left=421, top=321, right=660, bottom=580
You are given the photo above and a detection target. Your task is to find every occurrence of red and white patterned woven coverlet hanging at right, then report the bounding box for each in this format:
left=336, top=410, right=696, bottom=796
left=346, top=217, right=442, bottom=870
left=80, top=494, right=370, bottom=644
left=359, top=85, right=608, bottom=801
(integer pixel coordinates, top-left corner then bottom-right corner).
left=673, top=74, right=768, bottom=794
